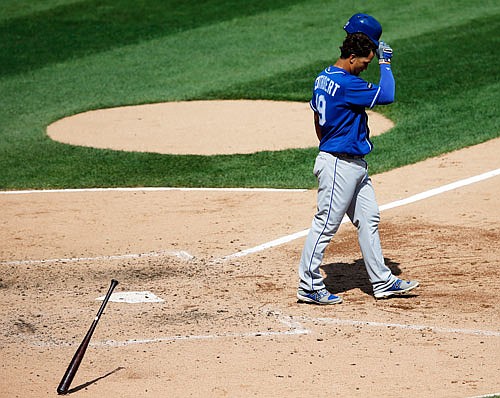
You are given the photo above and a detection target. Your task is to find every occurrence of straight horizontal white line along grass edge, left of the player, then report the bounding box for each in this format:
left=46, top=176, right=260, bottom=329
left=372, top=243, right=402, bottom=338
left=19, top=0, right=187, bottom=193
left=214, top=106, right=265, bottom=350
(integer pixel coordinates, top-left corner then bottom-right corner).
left=0, top=187, right=307, bottom=195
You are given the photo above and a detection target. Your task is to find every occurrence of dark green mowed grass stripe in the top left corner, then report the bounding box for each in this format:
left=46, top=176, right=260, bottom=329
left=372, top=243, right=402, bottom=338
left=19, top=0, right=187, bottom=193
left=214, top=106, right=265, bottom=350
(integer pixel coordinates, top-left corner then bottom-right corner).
left=0, top=0, right=304, bottom=75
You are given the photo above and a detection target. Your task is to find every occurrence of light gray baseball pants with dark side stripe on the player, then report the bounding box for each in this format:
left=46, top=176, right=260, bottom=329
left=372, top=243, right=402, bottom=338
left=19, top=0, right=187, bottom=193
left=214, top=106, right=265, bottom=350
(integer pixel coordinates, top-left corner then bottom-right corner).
left=299, top=152, right=397, bottom=293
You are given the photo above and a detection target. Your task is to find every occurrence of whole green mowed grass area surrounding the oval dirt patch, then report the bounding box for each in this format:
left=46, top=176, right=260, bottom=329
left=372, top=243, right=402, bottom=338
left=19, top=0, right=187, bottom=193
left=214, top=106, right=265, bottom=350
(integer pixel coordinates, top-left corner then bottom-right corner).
left=0, top=0, right=500, bottom=189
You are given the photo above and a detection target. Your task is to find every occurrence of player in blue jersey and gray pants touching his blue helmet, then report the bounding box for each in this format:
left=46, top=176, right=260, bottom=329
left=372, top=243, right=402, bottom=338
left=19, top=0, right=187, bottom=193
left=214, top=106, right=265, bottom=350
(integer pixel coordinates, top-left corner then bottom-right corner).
left=297, top=14, right=418, bottom=304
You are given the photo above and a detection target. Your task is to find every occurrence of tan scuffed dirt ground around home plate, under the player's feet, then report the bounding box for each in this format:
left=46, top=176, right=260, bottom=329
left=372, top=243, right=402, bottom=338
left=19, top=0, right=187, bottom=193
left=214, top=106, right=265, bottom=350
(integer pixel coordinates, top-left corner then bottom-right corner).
left=0, top=104, right=500, bottom=397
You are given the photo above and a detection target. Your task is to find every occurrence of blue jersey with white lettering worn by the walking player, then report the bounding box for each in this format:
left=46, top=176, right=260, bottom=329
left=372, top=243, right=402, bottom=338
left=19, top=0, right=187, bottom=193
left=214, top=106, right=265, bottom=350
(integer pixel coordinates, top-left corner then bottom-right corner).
left=310, top=65, right=394, bottom=156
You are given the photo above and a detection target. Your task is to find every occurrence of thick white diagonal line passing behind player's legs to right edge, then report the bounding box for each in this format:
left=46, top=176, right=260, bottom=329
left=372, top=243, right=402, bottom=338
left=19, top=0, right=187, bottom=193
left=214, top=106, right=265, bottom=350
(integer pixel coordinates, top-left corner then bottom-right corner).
left=221, top=169, right=500, bottom=261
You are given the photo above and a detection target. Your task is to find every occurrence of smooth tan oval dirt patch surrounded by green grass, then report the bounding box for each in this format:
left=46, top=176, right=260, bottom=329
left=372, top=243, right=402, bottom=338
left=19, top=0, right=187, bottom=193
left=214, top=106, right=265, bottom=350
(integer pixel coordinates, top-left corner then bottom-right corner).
left=47, top=100, right=393, bottom=155
